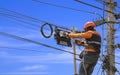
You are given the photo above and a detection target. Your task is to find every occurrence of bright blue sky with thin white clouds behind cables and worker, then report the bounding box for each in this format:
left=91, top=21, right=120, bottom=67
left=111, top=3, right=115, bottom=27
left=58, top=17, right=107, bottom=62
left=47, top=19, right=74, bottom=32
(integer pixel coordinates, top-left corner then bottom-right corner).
left=0, top=0, right=120, bottom=75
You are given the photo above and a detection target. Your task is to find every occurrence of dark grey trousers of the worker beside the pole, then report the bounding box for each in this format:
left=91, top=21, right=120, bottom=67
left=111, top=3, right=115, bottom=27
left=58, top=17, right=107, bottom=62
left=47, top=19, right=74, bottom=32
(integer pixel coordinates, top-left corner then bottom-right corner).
left=79, top=53, right=99, bottom=75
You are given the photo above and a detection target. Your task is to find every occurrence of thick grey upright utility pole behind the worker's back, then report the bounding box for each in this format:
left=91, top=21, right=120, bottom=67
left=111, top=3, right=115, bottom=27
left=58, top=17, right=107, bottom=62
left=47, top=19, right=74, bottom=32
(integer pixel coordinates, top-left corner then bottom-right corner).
left=105, top=0, right=116, bottom=75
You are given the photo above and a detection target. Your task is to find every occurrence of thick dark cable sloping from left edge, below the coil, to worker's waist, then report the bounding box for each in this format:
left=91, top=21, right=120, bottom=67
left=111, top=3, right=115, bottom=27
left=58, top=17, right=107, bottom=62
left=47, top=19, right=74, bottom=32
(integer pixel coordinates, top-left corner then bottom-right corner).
left=0, top=32, right=79, bottom=55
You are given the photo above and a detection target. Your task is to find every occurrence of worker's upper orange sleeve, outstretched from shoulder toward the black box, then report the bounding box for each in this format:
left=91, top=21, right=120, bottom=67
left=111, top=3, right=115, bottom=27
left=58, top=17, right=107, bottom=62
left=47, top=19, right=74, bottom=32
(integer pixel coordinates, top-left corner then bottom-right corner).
left=68, top=30, right=99, bottom=39
